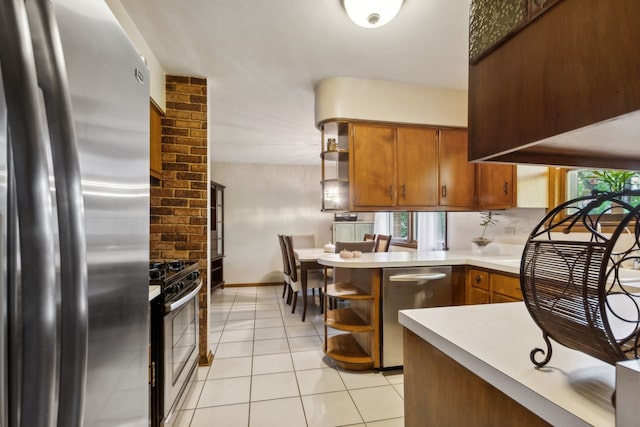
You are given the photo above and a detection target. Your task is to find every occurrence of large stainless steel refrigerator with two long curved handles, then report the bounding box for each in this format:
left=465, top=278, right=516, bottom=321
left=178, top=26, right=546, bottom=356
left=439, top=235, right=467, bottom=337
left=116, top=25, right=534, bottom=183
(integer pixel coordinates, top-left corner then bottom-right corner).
left=0, top=0, right=149, bottom=427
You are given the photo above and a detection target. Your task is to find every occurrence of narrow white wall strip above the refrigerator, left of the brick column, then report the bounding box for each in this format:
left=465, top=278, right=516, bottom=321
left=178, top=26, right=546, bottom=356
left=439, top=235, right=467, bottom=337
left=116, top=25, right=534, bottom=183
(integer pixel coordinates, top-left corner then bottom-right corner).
left=106, top=0, right=167, bottom=111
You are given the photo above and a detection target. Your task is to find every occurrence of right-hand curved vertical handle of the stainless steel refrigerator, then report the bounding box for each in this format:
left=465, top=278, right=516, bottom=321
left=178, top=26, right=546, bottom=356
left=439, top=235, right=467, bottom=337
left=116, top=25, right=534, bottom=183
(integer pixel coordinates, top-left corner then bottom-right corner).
left=25, top=0, right=89, bottom=427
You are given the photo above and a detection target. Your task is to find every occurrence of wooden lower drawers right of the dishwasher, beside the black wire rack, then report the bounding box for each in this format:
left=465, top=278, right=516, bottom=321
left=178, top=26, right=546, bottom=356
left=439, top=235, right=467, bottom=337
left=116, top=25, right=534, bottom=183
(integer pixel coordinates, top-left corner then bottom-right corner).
left=465, top=268, right=522, bottom=304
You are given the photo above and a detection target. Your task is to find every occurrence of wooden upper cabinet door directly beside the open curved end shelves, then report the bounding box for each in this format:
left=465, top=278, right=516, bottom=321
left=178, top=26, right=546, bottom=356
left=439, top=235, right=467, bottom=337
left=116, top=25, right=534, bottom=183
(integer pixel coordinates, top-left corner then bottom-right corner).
left=349, top=124, right=396, bottom=208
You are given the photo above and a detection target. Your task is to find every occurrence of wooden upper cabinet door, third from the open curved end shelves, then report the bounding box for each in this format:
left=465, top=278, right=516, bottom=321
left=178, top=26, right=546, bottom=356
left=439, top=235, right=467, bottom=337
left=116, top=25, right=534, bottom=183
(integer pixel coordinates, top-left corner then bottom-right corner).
left=438, top=129, right=476, bottom=210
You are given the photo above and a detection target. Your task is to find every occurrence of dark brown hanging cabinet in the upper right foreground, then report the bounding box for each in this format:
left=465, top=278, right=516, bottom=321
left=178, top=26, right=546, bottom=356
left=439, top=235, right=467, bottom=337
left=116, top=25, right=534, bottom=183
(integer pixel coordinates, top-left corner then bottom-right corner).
left=468, top=0, right=640, bottom=169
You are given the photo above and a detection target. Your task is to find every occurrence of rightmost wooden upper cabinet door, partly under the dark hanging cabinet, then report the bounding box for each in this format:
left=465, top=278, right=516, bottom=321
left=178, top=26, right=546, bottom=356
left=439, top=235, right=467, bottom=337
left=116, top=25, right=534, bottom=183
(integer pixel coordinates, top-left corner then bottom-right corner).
left=476, top=163, right=517, bottom=210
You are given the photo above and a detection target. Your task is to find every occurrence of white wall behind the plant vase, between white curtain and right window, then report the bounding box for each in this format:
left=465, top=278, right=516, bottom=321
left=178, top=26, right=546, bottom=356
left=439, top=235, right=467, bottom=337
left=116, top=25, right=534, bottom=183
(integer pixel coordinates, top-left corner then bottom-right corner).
left=447, top=208, right=545, bottom=255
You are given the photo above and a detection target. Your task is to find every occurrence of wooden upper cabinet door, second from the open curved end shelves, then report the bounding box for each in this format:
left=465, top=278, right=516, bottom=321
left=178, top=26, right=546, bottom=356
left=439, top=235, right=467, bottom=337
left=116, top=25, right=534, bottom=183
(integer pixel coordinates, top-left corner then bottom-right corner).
left=396, top=128, right=438, bottom=206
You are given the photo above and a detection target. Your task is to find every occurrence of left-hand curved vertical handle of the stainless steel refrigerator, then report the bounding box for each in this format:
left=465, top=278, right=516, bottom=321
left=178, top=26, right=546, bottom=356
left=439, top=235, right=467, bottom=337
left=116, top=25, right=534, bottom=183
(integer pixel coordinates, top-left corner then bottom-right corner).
left=0, top=0, right=58, bottom=427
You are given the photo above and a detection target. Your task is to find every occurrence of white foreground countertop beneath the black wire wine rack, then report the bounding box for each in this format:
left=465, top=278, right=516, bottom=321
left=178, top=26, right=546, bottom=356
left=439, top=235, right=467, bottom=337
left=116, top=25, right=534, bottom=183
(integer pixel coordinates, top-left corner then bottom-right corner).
left=399, top=302, right=615, bottom=426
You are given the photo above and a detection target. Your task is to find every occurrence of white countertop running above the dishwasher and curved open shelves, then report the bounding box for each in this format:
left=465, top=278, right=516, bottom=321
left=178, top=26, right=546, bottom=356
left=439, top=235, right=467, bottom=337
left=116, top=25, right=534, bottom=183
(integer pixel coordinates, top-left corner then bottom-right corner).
left=318, top=251, right=520, bottom=274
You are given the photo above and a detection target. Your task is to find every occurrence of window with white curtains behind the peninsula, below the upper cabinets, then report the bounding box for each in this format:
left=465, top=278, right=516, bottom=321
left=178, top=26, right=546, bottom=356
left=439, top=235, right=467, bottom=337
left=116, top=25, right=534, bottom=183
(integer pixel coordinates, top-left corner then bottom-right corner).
left=376, top=212, right=447, bottom=250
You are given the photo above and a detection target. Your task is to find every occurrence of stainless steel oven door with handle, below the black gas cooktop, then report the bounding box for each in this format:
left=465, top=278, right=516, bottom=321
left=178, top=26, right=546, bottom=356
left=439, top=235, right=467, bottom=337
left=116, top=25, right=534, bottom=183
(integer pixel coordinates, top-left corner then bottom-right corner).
left=161, top=279, right=202, bottom=426
